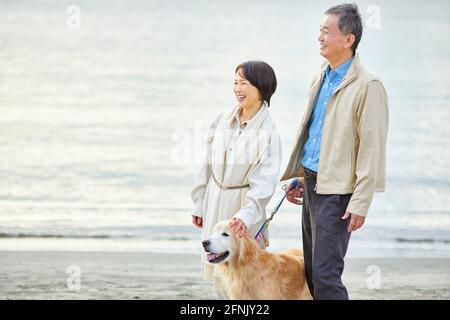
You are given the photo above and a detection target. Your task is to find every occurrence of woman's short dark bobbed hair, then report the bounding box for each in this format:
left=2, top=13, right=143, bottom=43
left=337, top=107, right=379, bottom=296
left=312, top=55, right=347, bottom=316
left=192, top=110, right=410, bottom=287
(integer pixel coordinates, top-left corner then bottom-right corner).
left=235, top=61, right=277, bottom=106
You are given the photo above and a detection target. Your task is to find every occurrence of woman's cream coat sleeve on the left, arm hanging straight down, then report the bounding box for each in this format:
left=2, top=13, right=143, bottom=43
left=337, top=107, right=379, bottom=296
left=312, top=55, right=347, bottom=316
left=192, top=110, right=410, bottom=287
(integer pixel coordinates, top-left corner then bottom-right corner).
left=191, top=115, right=222, bottom=217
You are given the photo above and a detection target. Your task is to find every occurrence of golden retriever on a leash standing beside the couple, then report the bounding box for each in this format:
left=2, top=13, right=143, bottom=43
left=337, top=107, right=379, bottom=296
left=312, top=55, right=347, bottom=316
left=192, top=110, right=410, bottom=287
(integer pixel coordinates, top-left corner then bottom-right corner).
left=202, top=220, right=312, bottom=300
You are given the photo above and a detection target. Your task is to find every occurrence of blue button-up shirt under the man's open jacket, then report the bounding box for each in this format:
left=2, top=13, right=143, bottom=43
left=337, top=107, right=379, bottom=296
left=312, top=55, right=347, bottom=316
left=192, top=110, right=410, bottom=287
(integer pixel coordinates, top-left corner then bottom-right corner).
left=301, top=58, right=353, bottom=172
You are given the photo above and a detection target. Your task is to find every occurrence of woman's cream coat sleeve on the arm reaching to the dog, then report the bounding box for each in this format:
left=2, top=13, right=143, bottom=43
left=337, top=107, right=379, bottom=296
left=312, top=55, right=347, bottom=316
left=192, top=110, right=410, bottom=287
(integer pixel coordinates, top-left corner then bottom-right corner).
left=234, top=130, right=282, bottom=228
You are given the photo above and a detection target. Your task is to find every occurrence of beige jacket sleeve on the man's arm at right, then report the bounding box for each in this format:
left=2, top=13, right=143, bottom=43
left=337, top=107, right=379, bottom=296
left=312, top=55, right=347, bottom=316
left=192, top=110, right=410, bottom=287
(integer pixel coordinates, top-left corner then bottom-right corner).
left=347, top=80, right=389, bottom=217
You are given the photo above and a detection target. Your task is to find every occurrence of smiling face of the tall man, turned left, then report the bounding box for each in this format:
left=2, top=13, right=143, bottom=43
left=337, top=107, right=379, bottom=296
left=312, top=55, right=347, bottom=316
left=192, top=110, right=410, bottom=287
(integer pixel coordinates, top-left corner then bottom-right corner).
left=318, top=14, right=348, bottom=60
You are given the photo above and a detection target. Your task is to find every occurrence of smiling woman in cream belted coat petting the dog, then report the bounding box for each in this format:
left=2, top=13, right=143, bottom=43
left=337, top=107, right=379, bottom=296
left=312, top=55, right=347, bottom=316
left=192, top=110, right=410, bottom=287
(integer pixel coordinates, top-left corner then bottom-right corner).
left=191, top=61, right=281, bottom=279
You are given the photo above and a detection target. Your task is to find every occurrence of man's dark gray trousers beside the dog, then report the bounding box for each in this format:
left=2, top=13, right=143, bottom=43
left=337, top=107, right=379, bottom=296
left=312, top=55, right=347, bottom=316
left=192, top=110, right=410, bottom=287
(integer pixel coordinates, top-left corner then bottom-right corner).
left=302, top=177, right=351, bottom=300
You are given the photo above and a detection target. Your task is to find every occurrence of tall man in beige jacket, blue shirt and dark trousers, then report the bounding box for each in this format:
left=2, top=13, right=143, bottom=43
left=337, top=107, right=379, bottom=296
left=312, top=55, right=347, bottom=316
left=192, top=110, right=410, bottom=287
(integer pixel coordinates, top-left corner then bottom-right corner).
left=281, top=4, right=388, bottom=299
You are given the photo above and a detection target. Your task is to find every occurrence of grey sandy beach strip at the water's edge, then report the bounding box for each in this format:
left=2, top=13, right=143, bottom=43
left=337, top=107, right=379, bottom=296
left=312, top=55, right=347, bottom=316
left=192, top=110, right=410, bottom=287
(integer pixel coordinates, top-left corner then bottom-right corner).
left=0, top=251, right=450, bottom=300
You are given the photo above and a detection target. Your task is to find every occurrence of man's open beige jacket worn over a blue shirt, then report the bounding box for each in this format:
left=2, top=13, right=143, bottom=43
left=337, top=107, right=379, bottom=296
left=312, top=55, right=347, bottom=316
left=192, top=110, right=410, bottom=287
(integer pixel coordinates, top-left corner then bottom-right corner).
left=281, top=54, right=389, bottom=217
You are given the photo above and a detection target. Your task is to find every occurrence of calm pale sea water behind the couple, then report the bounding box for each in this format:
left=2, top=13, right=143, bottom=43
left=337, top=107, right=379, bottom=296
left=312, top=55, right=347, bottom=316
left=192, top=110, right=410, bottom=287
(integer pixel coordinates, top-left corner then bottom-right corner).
left=0, top=0, right=450, bottom=257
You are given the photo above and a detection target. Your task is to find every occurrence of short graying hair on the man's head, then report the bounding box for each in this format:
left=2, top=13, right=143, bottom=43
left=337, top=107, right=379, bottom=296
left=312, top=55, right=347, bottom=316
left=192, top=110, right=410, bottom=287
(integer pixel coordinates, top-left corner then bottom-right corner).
left=325, top=3, right=363, bottom=54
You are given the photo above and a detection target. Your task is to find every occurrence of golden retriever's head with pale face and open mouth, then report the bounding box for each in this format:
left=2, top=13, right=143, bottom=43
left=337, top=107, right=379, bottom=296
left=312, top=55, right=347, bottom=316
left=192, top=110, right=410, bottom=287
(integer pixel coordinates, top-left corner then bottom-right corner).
left=202, top=220, right=258, bottom=264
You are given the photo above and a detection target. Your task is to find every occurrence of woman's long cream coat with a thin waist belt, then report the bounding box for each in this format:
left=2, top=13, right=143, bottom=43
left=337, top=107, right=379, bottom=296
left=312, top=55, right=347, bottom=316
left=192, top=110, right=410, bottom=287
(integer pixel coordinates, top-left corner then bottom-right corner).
left=191, top=103, right=281, bottom=278
